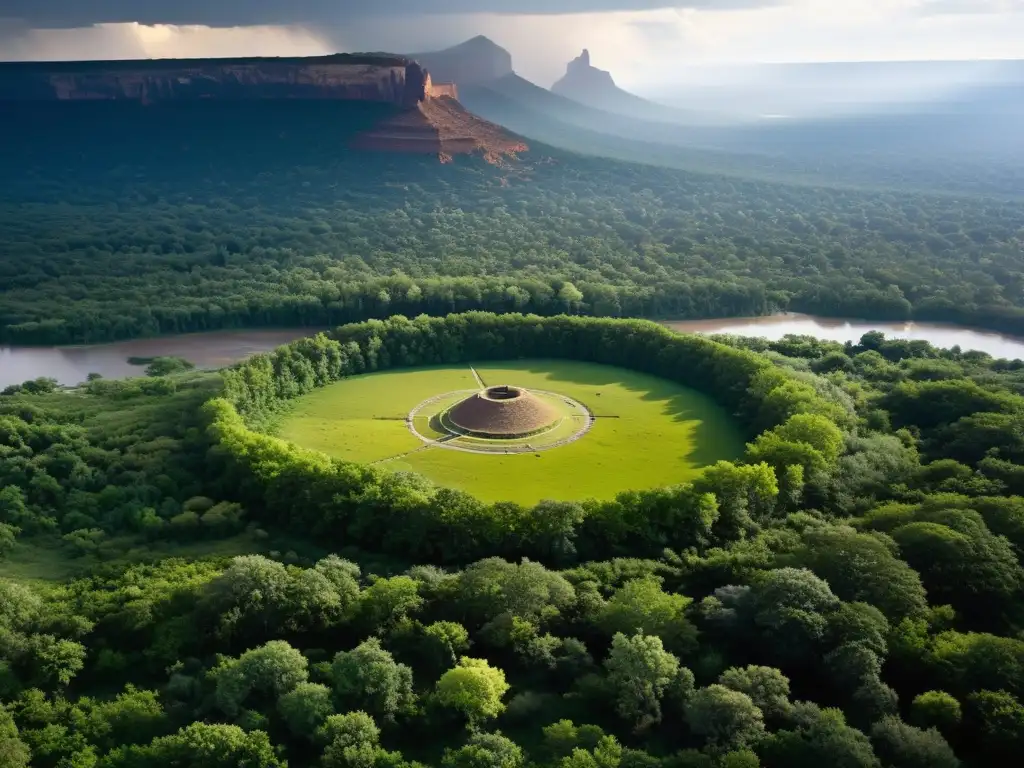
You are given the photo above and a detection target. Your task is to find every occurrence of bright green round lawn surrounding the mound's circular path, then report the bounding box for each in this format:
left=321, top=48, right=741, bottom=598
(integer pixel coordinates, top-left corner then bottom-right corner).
left=278, top=360, right=743, bottom=504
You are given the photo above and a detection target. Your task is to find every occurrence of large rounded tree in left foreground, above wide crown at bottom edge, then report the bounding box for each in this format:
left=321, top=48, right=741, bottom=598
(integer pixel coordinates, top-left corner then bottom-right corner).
left=210, top=640, right=309, bottom=716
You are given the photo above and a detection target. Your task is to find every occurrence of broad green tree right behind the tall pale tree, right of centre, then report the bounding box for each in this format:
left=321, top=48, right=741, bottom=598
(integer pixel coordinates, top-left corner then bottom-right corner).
left=598, top=577, right=697, bottom=655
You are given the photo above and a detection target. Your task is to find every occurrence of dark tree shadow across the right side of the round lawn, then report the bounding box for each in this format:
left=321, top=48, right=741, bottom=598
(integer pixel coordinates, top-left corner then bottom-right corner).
left=473, top=358, right=744, bottom=467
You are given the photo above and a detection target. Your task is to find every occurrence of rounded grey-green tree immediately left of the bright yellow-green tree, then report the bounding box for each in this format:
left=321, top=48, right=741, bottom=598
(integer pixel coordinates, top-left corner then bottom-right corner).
left=331, top=638, right=416, bottom=720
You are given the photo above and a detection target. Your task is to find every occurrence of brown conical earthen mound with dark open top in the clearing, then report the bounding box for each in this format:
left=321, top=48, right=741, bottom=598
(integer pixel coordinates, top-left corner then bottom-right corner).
left=447, top=385, right=559, bottom=437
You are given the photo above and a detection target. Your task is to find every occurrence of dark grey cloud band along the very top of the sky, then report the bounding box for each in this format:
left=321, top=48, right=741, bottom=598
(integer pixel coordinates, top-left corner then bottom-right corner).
left=0, top=0, right=781, bottom=27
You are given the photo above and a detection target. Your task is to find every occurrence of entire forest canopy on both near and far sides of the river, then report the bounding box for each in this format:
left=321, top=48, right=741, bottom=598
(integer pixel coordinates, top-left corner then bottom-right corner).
left=0, top=83, right=1024, bottom=768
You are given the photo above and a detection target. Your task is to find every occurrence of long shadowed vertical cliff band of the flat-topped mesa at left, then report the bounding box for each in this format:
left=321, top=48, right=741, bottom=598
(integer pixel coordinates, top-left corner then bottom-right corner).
left=0, top=54, right=432, bottom=109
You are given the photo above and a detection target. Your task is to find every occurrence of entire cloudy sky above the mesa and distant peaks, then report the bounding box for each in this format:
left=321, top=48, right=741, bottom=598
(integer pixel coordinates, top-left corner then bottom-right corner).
left=0, top=0, right=1024, bottom=90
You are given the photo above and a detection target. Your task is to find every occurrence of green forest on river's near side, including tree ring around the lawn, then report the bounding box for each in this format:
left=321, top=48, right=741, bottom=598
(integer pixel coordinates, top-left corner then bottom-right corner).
left=8, top=313, right=1024, bottom=768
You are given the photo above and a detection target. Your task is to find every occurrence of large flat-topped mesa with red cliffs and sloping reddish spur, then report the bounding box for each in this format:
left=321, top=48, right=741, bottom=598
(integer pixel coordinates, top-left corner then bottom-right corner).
left=0, top=53, right=528, bottom=163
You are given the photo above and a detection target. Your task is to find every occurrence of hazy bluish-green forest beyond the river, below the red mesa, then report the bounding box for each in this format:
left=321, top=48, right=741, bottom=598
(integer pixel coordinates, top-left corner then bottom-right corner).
left=0, top=102, right=1024, bottom=344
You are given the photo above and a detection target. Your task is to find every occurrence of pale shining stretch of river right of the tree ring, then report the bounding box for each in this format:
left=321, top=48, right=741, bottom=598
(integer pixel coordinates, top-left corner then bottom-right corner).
left=665, top=314, right=1024, bottom=359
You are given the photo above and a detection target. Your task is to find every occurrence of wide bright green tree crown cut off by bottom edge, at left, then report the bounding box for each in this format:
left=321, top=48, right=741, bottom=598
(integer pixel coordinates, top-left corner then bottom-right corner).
left=99, top=723, right=287, bottom=768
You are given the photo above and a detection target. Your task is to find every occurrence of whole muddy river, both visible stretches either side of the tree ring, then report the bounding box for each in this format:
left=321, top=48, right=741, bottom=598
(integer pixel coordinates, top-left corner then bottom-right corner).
left=0, top=314, right=1024, bottom=387
